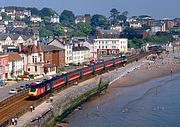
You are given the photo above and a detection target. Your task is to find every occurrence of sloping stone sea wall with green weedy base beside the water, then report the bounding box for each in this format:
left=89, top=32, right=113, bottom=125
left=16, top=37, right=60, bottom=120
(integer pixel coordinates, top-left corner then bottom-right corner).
left=24, top=78, right=109, bottom=127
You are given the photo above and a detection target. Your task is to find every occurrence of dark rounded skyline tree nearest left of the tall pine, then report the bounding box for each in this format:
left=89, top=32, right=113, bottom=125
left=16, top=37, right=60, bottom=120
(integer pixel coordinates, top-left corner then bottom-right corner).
left=91, top=14, right=109, bottom=28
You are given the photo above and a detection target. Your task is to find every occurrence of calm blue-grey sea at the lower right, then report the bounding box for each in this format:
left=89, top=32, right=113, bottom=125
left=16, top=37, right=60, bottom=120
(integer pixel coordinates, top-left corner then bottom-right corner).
left=67, top=74, right=180, bottom=127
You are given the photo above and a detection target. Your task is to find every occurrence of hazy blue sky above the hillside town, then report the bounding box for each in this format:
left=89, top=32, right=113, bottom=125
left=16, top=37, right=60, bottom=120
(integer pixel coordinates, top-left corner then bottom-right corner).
left=0, top=0, right=180, bottom=19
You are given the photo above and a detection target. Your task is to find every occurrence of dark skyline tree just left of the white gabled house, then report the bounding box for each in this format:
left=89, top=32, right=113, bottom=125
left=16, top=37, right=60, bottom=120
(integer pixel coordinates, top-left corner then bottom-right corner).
left=40, top=8, right=57, bottom=17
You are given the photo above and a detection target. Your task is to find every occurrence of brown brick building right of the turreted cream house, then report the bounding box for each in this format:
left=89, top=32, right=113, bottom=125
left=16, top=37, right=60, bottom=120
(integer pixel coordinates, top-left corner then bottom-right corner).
left=42, top=45, right=65, bottom=66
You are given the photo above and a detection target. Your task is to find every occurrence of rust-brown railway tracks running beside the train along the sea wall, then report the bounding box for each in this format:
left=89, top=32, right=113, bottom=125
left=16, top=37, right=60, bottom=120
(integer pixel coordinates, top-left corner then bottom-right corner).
left=0, top=54, right=147, bottom=127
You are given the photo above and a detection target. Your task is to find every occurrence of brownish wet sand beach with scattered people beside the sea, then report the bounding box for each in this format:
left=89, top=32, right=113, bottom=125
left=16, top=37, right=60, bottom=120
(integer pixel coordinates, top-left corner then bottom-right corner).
left=110, top=58, right=180, bottom=89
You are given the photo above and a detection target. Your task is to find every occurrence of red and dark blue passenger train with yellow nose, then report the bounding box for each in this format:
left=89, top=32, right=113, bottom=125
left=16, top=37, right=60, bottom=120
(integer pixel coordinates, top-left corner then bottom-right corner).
left=29, top=55, right=127, bottom=99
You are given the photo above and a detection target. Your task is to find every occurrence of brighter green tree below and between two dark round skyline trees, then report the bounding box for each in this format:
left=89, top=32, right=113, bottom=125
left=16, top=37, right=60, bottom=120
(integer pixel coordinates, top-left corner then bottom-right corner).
left=77, top=22, right=92, bottom=36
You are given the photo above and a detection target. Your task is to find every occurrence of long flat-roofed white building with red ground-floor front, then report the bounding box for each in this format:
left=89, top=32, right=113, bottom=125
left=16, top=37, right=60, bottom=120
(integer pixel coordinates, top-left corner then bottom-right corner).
left=94, top=38, right=128, bottom=55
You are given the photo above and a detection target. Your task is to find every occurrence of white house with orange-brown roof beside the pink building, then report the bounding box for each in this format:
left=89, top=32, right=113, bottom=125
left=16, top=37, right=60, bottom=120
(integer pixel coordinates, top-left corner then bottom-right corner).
left=8, top=53, right=24, bottom=79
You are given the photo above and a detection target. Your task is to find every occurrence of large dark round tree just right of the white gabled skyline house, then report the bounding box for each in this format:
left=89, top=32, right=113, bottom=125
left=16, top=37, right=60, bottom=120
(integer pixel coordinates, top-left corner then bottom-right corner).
left=60, top=10, right=75, bottom=26
